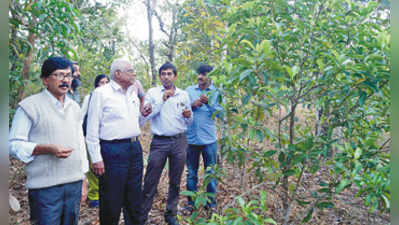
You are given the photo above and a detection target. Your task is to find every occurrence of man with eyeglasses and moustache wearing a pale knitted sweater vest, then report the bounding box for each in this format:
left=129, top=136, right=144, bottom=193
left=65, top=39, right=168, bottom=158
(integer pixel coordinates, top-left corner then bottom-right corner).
left=9, top=57, right=88, bottom=225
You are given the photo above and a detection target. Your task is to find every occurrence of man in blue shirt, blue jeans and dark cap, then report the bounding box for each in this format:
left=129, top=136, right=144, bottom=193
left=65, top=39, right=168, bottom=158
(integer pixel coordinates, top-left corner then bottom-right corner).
left=186, top=64, right=223, bottom=212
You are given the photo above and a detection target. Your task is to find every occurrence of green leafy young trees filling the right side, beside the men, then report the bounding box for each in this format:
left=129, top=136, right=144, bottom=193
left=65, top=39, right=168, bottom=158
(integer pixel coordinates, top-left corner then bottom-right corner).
left=177, top=0, right=390, bottom=222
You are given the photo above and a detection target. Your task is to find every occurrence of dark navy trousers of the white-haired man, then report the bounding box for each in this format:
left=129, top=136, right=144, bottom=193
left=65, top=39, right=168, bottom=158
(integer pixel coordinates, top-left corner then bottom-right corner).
left=99, top=141, right=143, bottom=225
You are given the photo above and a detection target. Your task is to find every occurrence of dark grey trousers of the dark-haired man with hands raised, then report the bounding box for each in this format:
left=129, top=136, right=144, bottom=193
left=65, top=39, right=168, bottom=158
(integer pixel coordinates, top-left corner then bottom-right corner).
left=142, top=134, right=187, bottom=221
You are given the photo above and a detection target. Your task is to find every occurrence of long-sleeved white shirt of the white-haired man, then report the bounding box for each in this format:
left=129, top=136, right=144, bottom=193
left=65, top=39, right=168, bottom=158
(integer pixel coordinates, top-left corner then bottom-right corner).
left=86, top=80, right=141, bottom=163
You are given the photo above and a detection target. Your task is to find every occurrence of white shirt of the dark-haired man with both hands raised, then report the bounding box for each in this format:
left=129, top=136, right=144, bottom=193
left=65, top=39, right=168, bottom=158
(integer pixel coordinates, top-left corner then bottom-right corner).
left=144, top=86, right=193, bottom=136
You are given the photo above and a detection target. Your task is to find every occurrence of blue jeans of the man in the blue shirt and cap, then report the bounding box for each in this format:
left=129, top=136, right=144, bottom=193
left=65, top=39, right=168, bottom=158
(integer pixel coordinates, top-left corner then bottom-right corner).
left=187, top=142, right=217, bottom=207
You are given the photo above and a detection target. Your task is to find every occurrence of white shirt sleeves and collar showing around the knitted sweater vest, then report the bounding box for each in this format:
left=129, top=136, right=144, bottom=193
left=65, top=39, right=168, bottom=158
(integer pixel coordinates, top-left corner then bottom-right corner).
left=8, top=89, right=89, bottom=173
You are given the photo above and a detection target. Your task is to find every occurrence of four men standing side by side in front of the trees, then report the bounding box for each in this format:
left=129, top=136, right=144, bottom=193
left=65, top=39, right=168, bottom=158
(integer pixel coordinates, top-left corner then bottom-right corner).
left=9, top=57, right=222, bottom=225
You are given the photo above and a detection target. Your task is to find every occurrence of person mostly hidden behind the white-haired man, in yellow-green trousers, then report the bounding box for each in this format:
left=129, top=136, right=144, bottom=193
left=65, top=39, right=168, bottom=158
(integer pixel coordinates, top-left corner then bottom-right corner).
left=82, top=74, right=109, bottom=208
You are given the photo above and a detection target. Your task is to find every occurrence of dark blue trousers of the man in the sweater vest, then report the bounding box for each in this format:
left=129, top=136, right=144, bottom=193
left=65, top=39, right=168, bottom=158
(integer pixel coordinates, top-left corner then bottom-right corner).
left=28, top=181, right=82, bottom=225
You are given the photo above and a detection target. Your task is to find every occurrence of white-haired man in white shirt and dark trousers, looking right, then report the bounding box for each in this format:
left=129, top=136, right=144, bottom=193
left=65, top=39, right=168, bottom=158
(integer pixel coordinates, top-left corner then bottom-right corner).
left=86, top=59, right=147, bottom=225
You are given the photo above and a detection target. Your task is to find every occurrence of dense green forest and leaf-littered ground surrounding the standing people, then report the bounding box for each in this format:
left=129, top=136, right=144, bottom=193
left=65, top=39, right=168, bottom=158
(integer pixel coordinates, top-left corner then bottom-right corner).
left=8, top=0, right=391, bottom=225
